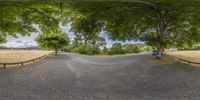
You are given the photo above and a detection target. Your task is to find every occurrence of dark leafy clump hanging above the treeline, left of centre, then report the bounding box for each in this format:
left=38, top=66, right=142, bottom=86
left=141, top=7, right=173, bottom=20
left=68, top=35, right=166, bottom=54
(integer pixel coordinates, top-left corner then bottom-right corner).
left=70, top=12, right=105, bottom=46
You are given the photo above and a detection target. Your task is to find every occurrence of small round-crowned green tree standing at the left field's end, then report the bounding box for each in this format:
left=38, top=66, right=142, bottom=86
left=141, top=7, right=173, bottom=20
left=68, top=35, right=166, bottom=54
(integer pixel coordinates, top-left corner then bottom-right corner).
left=36, top=30, right=70, bottom=55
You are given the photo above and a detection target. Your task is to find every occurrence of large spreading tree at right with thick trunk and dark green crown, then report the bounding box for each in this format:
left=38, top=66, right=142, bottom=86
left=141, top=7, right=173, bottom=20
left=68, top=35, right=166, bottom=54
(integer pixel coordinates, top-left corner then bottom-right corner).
left=66, top=0, right=200, bottom=58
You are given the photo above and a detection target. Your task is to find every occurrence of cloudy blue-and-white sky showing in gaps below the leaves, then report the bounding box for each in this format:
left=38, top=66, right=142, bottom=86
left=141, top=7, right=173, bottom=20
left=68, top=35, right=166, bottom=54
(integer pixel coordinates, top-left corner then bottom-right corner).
left=3, top=24, right=143, bottom=48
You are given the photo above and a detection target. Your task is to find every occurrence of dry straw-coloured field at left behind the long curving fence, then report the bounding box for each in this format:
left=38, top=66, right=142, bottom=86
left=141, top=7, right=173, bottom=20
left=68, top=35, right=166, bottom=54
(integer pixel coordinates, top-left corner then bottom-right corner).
left=0, top=50, right=52, bottom=63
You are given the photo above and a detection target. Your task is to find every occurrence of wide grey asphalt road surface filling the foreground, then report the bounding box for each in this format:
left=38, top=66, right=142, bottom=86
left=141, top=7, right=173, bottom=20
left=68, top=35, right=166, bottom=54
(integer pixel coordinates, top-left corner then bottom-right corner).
left=0, top=54, right=200, bottom=100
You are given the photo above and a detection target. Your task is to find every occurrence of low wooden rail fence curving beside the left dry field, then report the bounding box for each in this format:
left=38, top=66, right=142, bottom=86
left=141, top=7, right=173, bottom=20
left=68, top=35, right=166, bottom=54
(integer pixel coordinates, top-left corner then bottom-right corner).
left=0, top=54, right=49, bottom=68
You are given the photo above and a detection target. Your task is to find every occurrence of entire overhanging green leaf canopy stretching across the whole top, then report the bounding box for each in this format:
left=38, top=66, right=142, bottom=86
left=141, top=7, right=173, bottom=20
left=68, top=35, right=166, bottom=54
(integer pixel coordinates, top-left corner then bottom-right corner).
left=0, top=0, right=200, bottom=57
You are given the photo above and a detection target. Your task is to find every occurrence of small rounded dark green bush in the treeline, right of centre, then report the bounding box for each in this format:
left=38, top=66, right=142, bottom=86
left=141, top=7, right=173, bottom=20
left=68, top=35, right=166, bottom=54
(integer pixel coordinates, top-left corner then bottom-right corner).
left=109, top=43, right=125, bottom=55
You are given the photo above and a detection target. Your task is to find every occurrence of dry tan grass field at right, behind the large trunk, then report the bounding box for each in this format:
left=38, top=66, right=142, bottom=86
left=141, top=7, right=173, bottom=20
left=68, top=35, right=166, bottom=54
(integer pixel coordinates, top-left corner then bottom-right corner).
left=167, top=51, right=200, bottom=62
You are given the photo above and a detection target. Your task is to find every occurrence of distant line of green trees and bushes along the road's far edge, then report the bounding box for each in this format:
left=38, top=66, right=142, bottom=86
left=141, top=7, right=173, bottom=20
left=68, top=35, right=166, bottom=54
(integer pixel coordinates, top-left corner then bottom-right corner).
left=62, top=43, right=152, bottom=55
